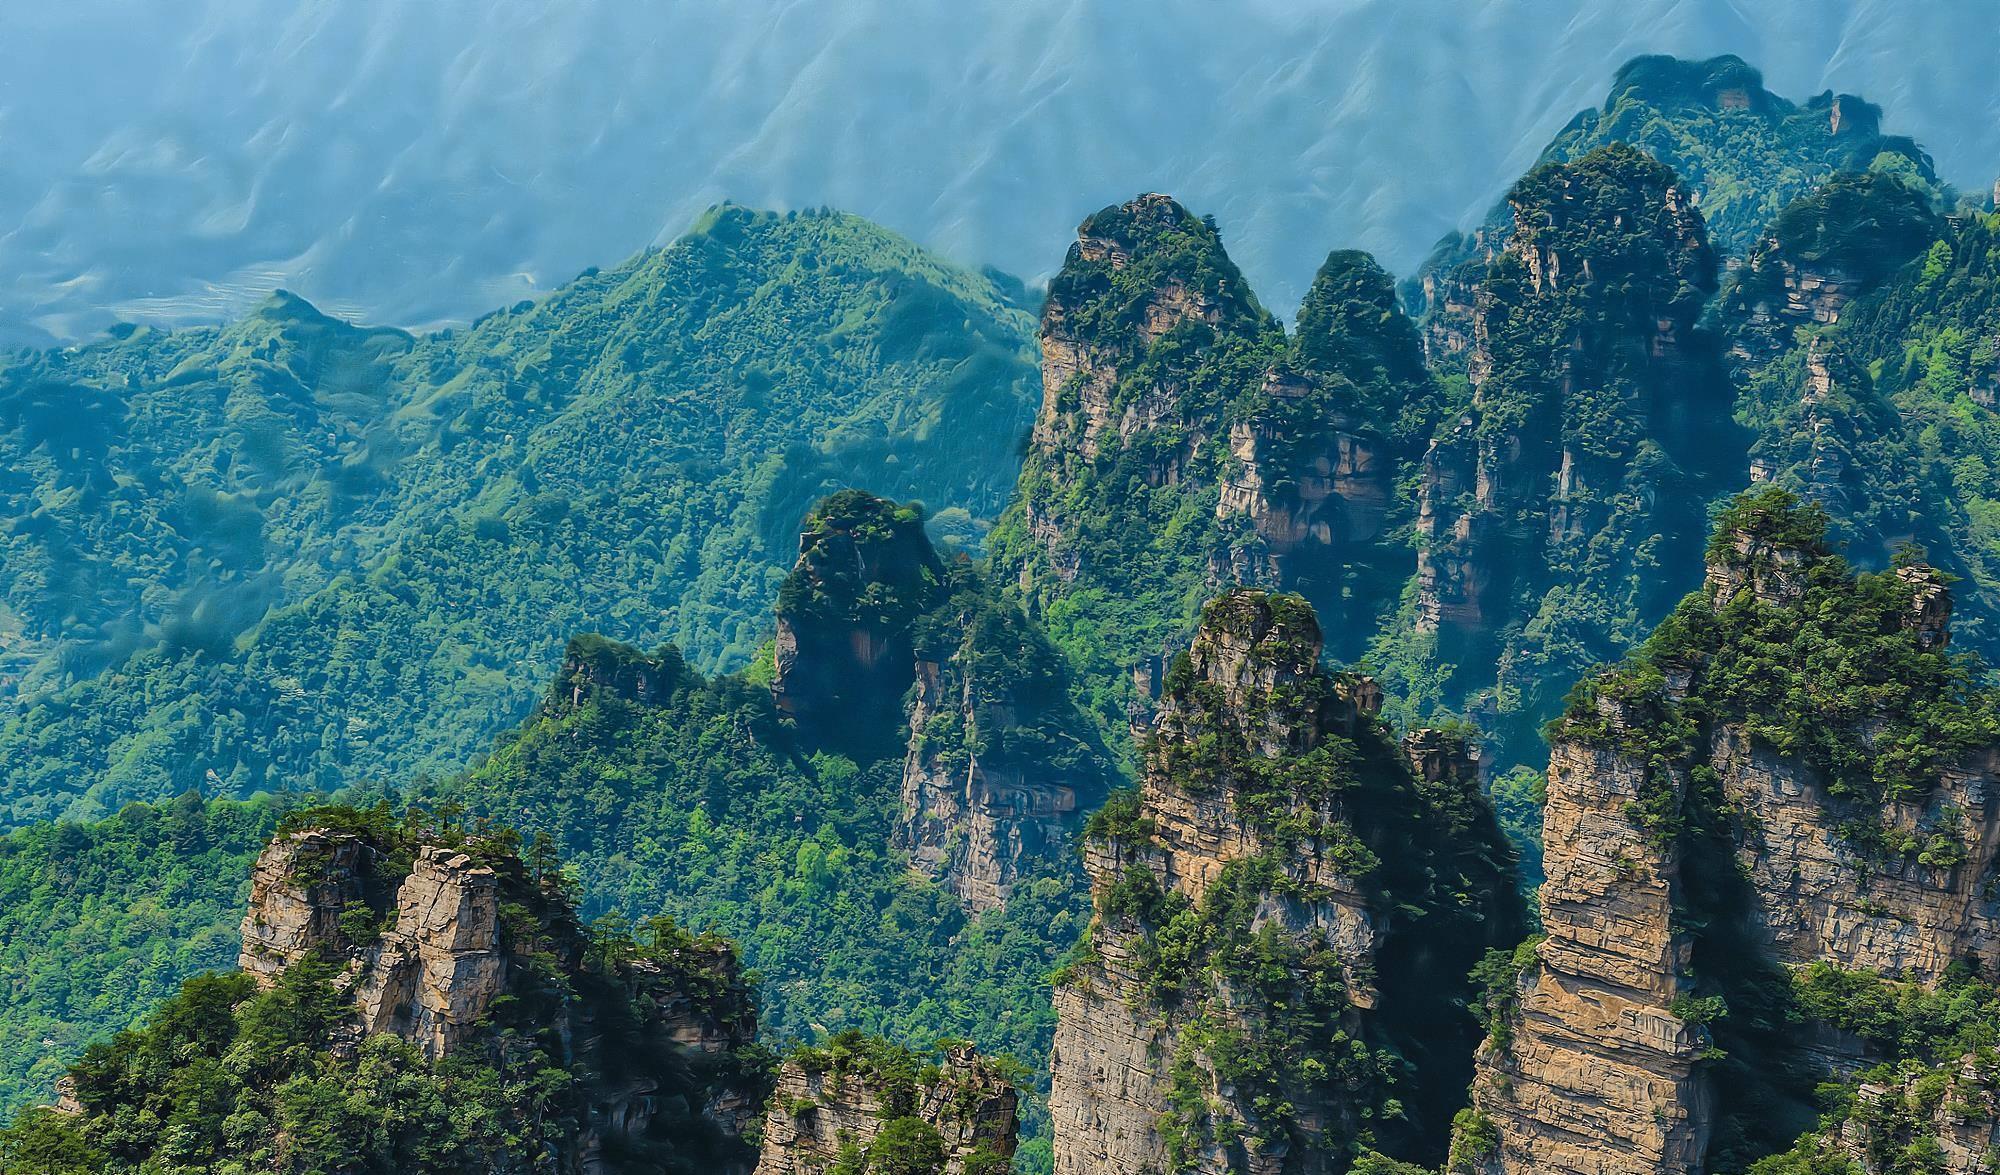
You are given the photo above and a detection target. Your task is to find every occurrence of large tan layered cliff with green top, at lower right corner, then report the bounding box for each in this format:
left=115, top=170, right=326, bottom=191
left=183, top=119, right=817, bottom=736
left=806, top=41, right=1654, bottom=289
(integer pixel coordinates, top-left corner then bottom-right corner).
left=1454, top=490, right=2000, bottom=1175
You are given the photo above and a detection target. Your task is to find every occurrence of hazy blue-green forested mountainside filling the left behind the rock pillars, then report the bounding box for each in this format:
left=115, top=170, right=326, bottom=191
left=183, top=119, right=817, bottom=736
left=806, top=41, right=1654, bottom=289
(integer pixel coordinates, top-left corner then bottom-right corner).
left=0, top=208, right=1032, bottom=823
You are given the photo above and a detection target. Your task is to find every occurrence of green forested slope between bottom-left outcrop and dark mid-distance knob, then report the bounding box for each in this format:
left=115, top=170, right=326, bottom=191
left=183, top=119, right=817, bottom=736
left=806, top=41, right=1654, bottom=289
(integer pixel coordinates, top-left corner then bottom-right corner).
left=434, top=639, right=1082, bottom=1087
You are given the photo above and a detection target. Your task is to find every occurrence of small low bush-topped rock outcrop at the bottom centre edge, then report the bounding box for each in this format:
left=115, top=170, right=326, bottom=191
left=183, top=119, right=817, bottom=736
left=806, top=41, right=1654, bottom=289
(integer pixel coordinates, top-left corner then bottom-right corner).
left=756, top=1039, right=1020, bottom=1175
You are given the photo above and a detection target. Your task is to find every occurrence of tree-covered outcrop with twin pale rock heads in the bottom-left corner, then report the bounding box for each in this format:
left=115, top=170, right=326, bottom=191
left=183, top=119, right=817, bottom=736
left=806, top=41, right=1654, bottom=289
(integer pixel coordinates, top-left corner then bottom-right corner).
left=0, top=807, right=770, bottom=1175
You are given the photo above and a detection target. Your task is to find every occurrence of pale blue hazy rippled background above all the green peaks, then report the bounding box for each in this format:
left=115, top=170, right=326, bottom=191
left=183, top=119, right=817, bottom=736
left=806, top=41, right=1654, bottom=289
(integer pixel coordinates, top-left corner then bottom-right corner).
left=0, top=0, right=2000, bottom=342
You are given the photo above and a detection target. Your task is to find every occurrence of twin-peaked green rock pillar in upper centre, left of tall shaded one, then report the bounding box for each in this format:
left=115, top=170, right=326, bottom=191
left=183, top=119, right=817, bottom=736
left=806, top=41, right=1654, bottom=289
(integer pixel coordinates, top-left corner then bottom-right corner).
left=992, top=194, right=1436, bottom=727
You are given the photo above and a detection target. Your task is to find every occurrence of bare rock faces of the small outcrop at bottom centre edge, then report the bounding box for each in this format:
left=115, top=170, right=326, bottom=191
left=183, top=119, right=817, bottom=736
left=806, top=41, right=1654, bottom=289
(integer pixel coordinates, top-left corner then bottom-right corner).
left=756, top=1045, right=1018, bottom=1175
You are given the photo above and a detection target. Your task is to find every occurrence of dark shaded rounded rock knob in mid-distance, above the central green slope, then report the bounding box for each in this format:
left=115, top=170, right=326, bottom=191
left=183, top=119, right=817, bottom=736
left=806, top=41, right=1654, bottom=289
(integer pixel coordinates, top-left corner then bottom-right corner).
left=772, top=490, right=944, bottom=743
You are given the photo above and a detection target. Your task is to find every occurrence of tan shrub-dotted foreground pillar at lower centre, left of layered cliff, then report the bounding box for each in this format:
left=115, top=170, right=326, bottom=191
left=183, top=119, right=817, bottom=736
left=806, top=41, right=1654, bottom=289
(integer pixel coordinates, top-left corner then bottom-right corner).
left=1050, top=589, right=1512, bottom=1175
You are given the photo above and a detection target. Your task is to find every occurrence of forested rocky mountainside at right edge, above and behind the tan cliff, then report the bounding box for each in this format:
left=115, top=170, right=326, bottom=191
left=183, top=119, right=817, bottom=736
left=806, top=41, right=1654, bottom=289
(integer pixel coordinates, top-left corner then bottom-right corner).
left=1722, top=190, right=2000, bottom=657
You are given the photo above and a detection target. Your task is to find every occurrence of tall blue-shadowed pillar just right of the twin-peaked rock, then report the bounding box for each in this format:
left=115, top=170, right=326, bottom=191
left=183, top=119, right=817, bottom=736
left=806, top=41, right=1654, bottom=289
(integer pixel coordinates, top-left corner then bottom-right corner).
left=1412, top=146, right=1730, bottom=745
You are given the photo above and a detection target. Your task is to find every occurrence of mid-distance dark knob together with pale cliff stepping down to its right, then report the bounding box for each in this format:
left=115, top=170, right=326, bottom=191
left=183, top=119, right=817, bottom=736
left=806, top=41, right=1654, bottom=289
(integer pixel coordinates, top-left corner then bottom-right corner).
left=768, top=490, right=1114, bottom=911
